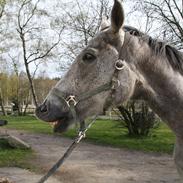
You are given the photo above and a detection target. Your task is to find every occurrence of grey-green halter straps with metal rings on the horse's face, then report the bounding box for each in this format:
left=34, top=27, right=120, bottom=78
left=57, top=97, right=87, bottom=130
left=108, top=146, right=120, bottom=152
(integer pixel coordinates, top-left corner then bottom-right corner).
left=52, top=59, right=124, bottom=121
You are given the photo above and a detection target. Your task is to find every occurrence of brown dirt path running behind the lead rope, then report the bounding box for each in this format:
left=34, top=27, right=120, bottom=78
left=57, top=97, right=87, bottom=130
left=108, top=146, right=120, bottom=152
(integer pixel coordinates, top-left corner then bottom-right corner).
left=0, top=133, right=180, bottom=183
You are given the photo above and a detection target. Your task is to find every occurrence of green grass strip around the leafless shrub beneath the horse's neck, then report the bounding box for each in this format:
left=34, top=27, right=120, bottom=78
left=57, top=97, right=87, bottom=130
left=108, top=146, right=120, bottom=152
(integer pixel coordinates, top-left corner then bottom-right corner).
left=63, top=120, right=175, bottom=153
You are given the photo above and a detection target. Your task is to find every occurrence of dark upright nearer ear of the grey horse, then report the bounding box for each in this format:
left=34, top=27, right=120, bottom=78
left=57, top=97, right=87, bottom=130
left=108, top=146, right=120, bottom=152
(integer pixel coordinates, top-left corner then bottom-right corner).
left=111, top=0, right=125, bottom=33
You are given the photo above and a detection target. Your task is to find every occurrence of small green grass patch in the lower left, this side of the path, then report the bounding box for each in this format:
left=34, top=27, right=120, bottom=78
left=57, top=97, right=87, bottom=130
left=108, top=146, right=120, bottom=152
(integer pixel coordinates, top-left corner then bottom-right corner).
left=0, top=139, right=34, bottom=169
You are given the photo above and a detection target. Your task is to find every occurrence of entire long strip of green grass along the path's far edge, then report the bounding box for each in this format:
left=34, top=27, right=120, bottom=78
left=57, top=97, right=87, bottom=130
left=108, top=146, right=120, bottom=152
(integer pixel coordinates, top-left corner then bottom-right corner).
left=1, top=116, right=175, bottom=153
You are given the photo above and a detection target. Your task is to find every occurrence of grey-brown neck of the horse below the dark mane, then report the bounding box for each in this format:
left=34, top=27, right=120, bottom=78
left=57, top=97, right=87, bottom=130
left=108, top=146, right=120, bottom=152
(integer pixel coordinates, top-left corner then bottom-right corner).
left=122, top=34, right=183, bottom=134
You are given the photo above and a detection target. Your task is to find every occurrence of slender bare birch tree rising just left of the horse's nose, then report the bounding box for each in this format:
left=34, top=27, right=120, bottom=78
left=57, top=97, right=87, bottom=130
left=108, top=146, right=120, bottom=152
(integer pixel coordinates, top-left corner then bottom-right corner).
left=3, top=0, right=64, bottom=106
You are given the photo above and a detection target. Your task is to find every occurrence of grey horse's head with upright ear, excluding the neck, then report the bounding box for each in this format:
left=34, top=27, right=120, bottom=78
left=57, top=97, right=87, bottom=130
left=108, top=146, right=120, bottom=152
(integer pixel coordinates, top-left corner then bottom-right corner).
left=36, top=0, right=136, bottom=132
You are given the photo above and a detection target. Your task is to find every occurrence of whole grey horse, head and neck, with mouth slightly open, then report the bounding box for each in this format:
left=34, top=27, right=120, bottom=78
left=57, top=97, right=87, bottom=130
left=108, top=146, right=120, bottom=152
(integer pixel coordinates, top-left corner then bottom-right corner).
left=36, top=0, right=183, bottom=181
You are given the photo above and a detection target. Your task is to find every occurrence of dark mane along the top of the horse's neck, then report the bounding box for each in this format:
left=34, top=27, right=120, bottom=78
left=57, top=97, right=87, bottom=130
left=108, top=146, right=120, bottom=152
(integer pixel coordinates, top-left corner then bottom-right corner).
left=123, top=26, right=183, bottom=75
